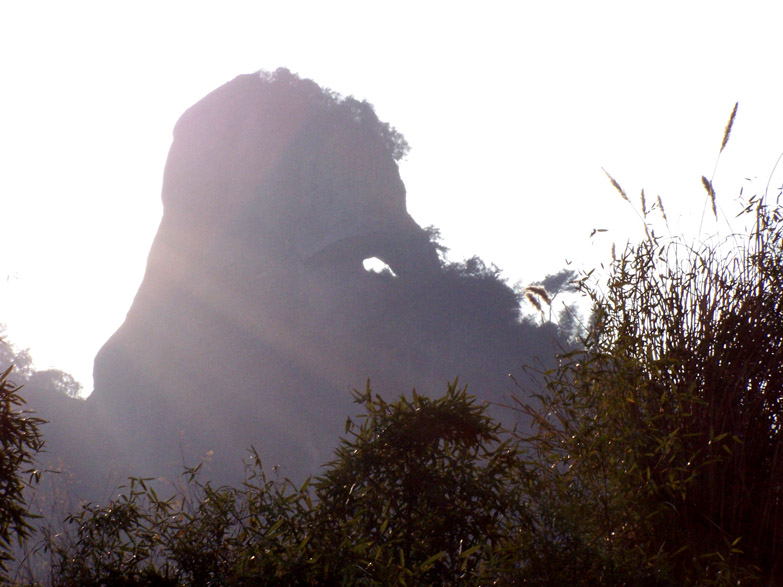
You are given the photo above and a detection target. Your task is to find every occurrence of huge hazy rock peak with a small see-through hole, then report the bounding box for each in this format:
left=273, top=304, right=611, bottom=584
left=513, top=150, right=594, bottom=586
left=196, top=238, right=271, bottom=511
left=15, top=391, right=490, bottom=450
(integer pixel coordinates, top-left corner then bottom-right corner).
left=39, top=70, right=552, bottom=496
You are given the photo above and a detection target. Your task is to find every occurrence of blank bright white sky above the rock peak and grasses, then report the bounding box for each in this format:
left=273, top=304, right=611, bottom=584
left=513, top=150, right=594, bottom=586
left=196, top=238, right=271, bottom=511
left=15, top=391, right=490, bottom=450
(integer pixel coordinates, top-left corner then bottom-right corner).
left=0, top=0, right=783, bottom=391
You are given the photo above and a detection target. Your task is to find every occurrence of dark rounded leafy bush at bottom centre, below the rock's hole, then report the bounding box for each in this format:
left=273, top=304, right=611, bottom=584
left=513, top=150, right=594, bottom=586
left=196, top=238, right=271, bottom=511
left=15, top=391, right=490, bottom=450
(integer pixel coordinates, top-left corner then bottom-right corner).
left=316, top=383, right=527, bottom=585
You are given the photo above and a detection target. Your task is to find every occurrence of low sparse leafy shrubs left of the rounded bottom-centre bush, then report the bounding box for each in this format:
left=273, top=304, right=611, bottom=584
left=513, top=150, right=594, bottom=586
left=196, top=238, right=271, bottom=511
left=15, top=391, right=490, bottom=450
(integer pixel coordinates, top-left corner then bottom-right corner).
left=45, top=465, right=313, bottom=586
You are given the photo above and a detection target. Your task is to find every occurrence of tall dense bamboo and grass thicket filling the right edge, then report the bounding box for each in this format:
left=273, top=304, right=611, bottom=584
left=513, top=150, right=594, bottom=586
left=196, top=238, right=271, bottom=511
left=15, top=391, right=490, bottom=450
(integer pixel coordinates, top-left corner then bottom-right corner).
left=520, top=192, right=783, bottom=585
